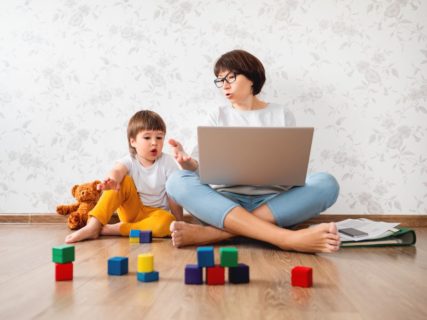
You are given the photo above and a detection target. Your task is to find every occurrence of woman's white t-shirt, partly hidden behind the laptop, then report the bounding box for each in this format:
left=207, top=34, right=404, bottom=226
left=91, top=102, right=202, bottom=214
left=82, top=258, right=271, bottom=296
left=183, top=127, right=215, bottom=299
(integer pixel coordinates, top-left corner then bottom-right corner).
left=191, top=103, right=296, bottom=195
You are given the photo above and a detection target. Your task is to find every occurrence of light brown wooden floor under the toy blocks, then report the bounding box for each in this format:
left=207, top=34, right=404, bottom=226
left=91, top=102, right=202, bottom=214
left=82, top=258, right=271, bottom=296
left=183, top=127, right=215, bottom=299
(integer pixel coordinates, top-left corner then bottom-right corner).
left=0, top=224, right=427, bottom=320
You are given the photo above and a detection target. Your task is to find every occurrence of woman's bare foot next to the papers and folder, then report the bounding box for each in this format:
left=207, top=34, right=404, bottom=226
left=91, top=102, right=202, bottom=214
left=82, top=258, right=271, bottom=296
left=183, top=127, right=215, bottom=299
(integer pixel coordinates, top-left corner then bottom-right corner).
left=280, top=222, right=340, bottom=252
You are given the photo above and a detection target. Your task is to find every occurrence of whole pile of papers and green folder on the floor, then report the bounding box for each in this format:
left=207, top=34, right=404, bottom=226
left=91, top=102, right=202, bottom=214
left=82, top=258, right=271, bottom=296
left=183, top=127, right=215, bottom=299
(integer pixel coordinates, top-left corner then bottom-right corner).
left=336, top=218, right=416, bottom=247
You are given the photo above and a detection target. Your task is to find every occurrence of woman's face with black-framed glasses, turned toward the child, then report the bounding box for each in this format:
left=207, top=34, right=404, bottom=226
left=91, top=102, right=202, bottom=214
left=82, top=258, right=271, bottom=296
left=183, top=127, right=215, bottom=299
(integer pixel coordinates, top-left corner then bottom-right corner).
left=217, top=70, right=253, bottom=103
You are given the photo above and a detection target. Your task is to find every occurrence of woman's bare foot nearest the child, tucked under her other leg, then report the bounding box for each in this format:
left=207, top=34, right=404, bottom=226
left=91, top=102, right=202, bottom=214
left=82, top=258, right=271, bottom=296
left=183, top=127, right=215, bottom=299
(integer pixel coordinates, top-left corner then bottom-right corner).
left=170, top=221, right=234, bottom=248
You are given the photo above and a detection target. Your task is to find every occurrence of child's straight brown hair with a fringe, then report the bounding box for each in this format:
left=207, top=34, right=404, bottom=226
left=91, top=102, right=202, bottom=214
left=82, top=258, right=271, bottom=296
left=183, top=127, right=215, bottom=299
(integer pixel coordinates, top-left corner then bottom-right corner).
left=127, top=110, right=166, bottom=156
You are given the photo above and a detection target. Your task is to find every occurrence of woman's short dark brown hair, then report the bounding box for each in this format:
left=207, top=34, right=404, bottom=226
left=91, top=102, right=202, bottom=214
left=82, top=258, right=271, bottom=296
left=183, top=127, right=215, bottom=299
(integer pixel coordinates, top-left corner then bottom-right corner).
left=214, top=50, right=265, bottom=96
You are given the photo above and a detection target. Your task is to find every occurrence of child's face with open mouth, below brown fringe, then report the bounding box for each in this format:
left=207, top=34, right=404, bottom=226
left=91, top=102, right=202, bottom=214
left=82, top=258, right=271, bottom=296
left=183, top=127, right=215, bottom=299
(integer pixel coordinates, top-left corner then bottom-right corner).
left=130, top=130, right=165, bottom=165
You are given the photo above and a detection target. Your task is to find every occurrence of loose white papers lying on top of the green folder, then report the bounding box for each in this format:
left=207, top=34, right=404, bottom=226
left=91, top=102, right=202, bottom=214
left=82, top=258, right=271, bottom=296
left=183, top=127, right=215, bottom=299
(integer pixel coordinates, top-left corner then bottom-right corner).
left=336, top=218, right=399, bottom=241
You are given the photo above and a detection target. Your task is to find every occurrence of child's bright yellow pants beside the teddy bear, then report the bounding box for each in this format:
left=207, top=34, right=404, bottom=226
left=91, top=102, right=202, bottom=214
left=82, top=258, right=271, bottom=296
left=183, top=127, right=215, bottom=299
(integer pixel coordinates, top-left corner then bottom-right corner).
left=89, top=176, right=175, bottom=237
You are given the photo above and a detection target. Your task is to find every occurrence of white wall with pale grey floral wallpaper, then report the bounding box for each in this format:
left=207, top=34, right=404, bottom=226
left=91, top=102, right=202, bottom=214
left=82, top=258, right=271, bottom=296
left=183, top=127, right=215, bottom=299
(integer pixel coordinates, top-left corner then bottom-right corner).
left=0, top=0, right=427, bottom=214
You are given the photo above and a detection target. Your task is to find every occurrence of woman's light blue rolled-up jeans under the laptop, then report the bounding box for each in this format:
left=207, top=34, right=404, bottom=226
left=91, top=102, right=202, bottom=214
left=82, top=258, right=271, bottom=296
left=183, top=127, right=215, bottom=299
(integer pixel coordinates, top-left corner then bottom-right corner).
left=166, top=170, right=339, bottom=229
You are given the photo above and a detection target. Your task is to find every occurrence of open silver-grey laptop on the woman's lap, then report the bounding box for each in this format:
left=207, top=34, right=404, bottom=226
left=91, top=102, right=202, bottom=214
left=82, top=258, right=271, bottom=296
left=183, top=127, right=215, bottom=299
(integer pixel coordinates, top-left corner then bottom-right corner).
left=197, top=127, right=314, bottom=186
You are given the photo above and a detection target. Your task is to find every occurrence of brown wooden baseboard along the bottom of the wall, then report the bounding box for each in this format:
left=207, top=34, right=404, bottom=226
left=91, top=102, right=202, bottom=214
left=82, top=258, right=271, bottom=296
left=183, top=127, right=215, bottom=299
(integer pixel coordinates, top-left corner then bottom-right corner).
left=0, top=214, right=427, bottom=228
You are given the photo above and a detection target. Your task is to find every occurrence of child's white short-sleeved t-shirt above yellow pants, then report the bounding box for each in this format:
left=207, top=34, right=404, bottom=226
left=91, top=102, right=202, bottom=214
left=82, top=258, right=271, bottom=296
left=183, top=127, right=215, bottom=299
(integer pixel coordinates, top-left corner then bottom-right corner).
left=117, top=153, right=179, bottom=210
